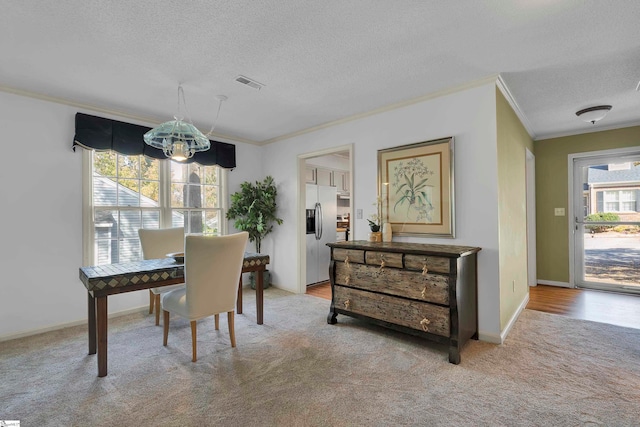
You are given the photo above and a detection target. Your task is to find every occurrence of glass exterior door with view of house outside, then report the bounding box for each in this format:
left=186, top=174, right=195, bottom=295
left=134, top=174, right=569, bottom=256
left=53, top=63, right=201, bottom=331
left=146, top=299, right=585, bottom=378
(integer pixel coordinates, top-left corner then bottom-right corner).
left=569, top=148, right=640, bottom=293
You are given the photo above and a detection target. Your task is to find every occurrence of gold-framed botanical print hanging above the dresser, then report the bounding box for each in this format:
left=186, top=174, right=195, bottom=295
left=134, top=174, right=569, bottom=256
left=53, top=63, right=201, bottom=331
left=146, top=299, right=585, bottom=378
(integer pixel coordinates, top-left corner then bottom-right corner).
left=378, top=137, right=455, bottom=238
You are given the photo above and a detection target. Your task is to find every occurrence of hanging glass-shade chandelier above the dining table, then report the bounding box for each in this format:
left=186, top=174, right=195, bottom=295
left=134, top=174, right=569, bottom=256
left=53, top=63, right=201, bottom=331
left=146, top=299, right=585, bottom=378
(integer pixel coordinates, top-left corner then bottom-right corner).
left=144, top=85, right=227, bottom=162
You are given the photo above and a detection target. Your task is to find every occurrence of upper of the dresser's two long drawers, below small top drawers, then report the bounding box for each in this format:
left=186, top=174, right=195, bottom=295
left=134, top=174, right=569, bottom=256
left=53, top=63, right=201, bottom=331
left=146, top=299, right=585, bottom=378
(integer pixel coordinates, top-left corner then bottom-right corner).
left=335, top=262, right=449, bottom=305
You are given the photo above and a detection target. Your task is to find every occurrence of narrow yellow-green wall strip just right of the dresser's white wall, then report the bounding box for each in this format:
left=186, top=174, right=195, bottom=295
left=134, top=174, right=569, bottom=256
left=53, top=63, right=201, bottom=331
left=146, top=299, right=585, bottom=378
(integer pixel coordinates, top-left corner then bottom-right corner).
left=496, top=88, right=533, bottom=330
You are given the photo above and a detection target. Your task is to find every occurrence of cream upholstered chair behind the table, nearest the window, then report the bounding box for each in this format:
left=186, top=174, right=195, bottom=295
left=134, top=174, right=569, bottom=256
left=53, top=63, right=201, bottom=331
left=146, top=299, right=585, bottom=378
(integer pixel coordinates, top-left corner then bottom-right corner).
left=138, top=227, right=184, bottom=325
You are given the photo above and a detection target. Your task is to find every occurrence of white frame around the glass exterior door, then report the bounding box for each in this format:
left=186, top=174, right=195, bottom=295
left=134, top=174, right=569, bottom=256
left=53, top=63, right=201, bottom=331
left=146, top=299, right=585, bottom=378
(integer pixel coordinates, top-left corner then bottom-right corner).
left=567, top=147, right=640, bottom=288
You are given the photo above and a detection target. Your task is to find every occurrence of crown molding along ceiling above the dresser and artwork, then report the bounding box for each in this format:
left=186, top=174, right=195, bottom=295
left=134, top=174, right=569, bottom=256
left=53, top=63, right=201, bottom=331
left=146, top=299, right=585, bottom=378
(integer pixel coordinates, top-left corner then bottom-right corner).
left=261, top=74, right=499, bottom=145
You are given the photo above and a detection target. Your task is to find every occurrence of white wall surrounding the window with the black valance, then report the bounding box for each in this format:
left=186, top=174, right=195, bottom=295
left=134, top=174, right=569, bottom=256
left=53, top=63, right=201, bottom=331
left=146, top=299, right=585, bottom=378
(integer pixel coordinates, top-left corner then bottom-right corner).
left=0, top=92, right=263, bottom=340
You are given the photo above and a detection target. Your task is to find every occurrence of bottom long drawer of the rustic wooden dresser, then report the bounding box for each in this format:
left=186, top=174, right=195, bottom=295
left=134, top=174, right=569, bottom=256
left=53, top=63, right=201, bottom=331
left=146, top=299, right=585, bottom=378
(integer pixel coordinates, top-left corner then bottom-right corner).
left=333, top=286, right=450, bottom=337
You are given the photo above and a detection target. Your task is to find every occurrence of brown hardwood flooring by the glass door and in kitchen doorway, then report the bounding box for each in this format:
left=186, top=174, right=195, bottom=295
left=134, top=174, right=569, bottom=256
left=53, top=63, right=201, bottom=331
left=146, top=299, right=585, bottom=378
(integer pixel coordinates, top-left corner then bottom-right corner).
left=307, top=282, right=640, bottom=329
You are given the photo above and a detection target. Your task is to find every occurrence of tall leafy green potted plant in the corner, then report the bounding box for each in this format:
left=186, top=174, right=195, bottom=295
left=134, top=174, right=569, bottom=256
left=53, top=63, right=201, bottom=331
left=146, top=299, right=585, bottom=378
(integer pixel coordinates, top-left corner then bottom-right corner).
left=227, top=176, right=282, bottom=289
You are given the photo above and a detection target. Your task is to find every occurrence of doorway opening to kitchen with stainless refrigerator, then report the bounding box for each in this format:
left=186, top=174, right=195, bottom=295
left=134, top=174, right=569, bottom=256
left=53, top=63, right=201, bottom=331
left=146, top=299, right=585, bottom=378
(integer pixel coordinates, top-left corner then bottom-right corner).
left=298, top=145, right=353, bottom=293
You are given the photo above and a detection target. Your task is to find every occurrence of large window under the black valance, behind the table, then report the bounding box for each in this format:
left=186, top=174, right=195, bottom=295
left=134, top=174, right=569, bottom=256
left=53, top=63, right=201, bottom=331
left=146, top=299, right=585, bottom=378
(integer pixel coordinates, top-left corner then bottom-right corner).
left=84, top=151, right=225, bottom=265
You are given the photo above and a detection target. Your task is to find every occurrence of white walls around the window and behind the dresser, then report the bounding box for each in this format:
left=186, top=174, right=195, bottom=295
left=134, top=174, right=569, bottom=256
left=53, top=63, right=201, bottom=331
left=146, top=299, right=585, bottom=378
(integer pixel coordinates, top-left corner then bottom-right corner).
left=0, top=84, right=500, bottom=339
